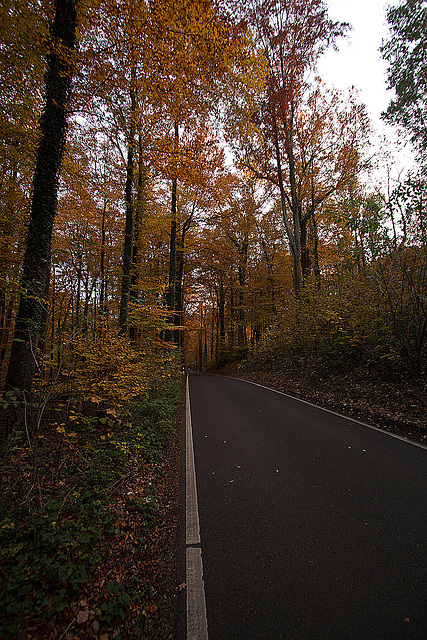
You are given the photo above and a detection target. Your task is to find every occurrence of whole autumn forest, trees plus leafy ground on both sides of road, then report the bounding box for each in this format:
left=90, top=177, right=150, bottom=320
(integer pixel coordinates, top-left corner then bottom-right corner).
left=0, top=0, right=427, bottom=640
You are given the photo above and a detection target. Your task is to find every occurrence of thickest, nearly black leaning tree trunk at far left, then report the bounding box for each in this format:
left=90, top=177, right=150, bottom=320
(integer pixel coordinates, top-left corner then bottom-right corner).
left=6, top=0, right=78, bottom=391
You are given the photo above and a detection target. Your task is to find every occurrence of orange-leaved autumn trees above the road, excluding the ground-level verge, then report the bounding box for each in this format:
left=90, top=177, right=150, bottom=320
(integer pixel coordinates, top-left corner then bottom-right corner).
left=0, top=0, right=427, bottom=436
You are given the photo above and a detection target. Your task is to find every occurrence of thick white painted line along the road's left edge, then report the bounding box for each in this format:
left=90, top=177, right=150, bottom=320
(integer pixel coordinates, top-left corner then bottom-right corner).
left=185, top=375, right=208, bottom=640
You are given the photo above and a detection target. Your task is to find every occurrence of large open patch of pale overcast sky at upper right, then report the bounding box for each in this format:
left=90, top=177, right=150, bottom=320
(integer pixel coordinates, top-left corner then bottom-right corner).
left=319, top=0, right=397, bottom=127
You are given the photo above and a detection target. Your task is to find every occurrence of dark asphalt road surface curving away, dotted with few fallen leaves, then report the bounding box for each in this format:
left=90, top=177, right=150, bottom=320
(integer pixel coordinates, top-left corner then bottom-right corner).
left=190, top=374, right=427, bottom=640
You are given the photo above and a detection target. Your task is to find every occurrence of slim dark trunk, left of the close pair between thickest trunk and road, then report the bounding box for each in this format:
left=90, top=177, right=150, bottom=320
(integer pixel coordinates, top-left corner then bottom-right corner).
left=119, top=79, right=136, bottom=333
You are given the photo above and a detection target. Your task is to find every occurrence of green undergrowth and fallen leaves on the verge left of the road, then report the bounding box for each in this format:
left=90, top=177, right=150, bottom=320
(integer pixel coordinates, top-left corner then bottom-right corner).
left=0, top=373, right=181, bottom=640
